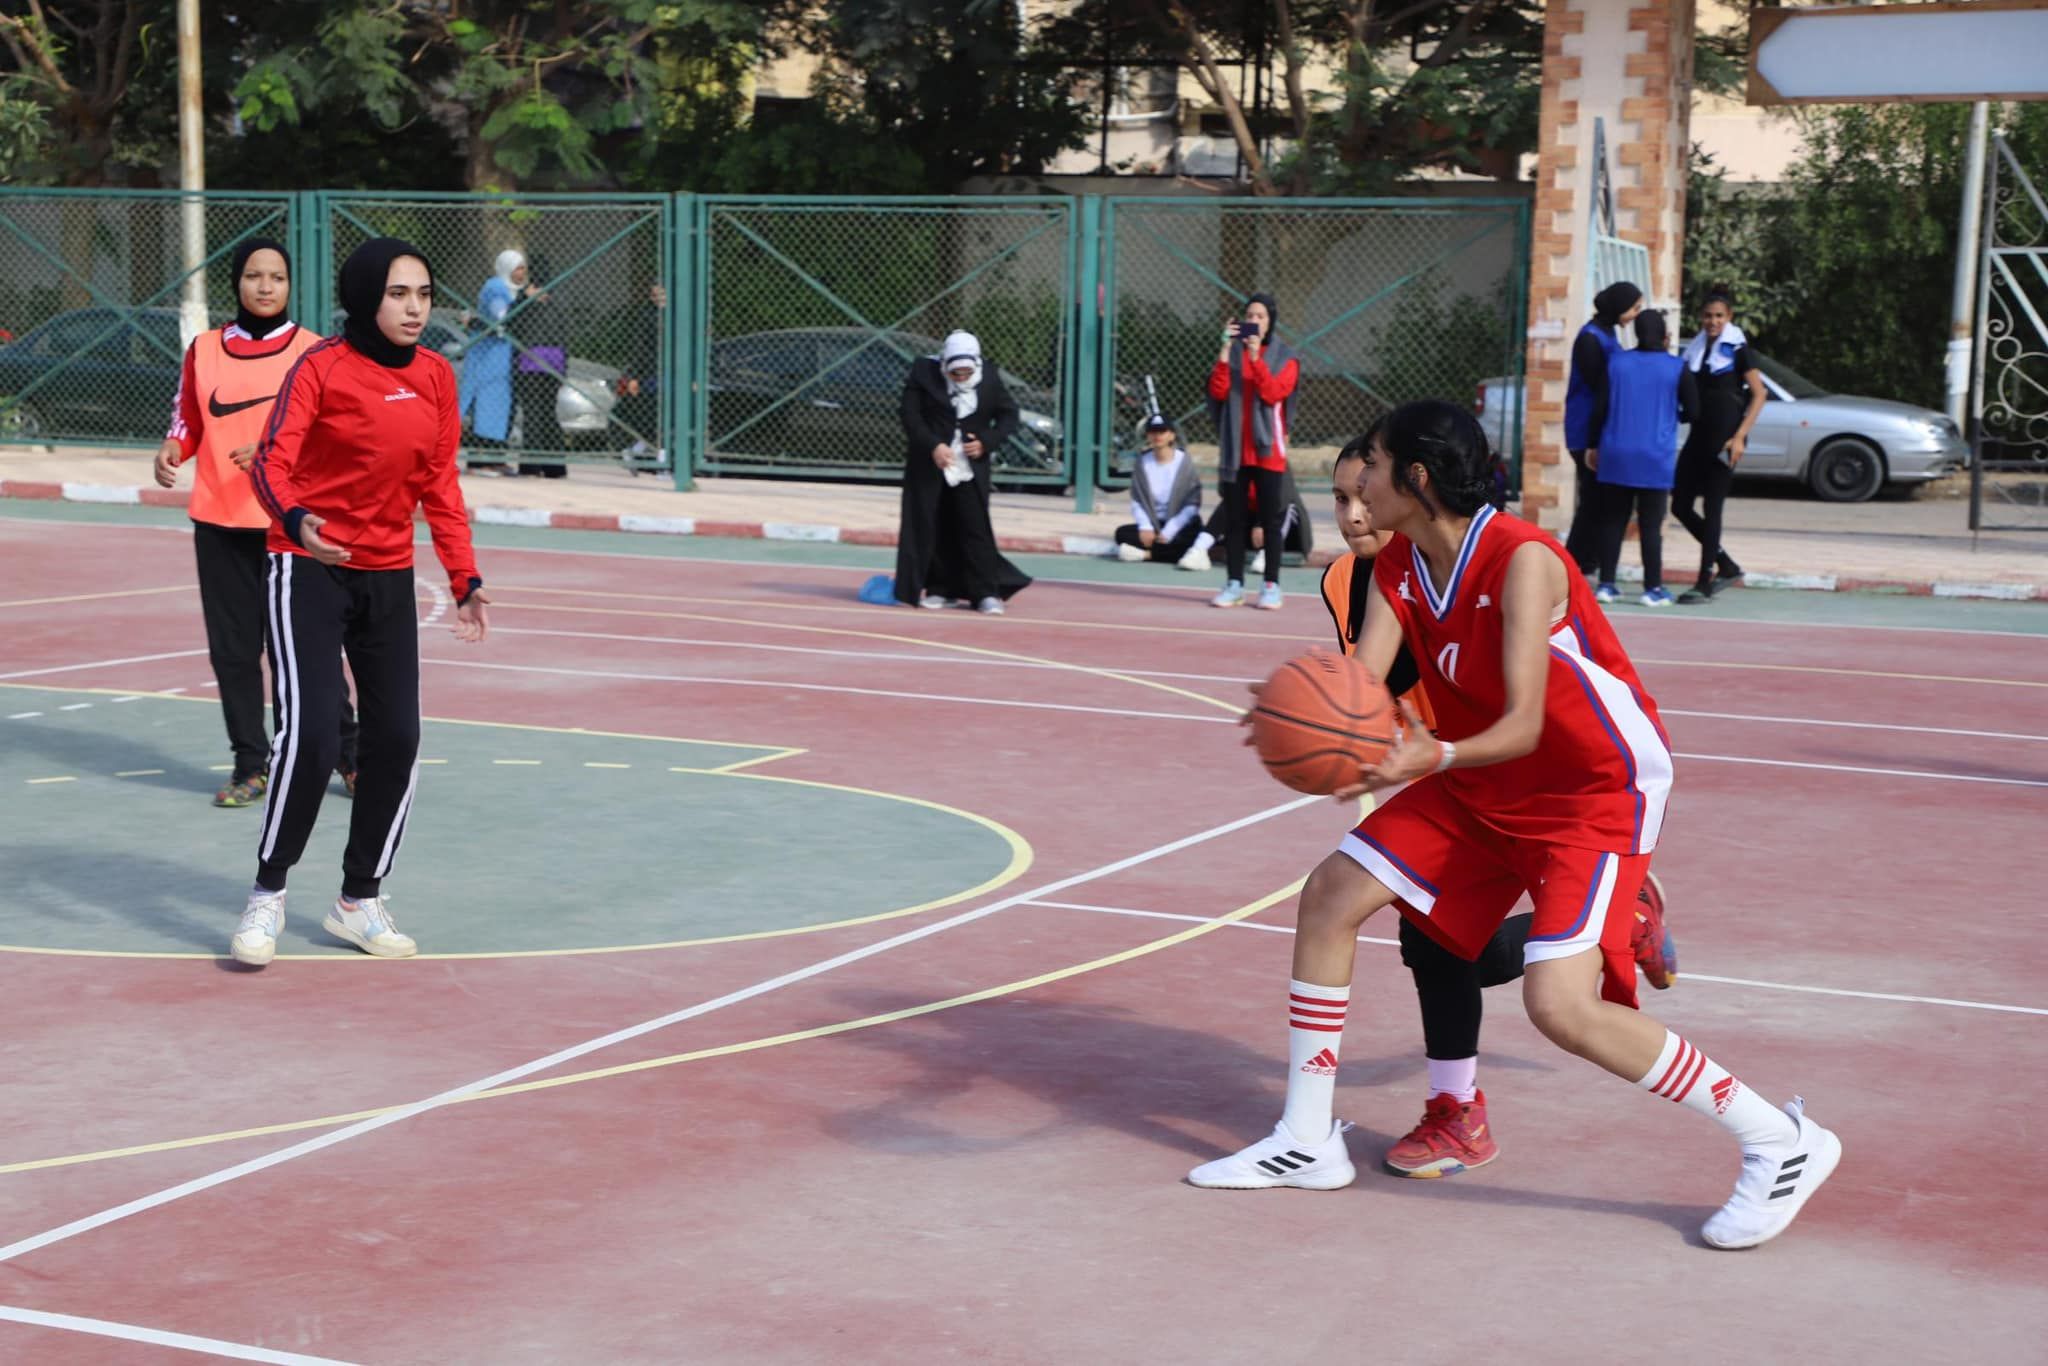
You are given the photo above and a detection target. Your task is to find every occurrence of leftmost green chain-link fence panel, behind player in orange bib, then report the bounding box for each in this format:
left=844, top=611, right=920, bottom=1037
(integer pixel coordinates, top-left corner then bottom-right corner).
left=0, top=188, right=299, bottom=446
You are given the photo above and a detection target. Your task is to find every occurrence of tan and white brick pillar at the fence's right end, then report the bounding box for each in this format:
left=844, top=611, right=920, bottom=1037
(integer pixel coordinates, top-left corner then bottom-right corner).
left=1522, top=0, right=1694, bottom=532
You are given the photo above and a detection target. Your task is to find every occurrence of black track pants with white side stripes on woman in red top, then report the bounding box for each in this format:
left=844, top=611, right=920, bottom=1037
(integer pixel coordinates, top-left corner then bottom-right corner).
left=256, top=553, right=420, bottom=897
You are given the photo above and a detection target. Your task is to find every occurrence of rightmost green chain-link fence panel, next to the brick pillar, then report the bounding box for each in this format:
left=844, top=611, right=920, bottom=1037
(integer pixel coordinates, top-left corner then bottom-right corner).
left=1098, top=199, right=1528, bottom=483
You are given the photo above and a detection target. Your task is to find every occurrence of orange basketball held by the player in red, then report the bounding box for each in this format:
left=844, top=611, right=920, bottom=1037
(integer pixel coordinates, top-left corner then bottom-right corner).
left=1251, top=649, right=1399, bottom=797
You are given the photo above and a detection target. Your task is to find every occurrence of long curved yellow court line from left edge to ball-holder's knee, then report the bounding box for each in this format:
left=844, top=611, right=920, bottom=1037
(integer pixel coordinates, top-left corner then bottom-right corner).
left=0, top=879, right=1307, bottom=1176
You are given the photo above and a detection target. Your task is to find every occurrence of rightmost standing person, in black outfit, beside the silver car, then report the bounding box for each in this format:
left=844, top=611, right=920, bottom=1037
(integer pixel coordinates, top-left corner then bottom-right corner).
left=1671, top=289, right=1765, bottom=606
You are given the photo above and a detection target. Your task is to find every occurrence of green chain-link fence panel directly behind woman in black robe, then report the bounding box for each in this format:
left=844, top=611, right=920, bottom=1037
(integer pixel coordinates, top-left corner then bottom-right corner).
left=694, top=197, right=1075, bottom=485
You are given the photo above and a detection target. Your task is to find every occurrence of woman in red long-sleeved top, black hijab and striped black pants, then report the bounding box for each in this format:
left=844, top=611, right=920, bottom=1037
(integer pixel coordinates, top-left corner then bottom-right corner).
left=229, top=238, right=489, bottom=967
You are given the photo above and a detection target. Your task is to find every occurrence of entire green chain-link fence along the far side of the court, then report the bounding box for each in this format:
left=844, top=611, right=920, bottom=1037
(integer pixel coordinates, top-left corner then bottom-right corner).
left=0, top=190, right=1528, bottom=506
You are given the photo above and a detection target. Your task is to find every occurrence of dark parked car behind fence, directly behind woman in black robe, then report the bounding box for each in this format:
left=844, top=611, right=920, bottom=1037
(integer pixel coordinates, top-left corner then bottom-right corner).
left=709, top=328, right=1065, bottom=473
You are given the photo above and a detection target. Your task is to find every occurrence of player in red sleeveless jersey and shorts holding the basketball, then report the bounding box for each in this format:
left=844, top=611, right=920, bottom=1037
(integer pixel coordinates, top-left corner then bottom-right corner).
left=1188, top=401, right=1841, bottom=1247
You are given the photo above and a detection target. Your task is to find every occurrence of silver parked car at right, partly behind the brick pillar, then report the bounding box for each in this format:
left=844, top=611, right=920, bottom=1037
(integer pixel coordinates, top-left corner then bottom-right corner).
left=1475, top=348, right=1970, bottom=502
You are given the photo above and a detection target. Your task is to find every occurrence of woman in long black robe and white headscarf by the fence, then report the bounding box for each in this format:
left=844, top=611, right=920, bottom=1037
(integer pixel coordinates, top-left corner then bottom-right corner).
left=895, top=332, right=1030, bottom=614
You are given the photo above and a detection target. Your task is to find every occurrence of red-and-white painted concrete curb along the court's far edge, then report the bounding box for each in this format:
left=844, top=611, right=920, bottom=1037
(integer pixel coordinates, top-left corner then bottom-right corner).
left=0, top=479, right=2048, bottom=602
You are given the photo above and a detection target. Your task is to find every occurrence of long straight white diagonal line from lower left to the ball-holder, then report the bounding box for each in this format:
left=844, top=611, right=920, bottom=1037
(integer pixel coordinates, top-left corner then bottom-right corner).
left=0, top=797, right=1325, bottom=1262
